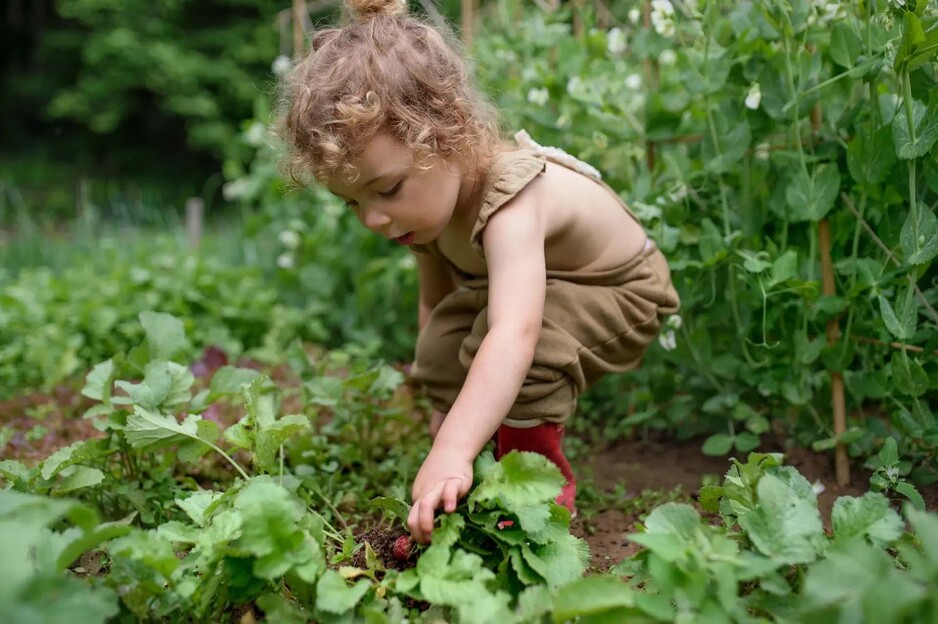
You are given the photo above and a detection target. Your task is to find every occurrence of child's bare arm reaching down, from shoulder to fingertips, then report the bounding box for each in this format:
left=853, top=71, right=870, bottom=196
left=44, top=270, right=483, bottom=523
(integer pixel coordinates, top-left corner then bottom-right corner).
left=407, top=196, right=547, bottom=543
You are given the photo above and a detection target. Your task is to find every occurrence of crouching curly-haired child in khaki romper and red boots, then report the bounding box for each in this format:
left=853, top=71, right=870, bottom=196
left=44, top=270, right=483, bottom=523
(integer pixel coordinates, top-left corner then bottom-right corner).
left=274, top=0, right=679, bottom=543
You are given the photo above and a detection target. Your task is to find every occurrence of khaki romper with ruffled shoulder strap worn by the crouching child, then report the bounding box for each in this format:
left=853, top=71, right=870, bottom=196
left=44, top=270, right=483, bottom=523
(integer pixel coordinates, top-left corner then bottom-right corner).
left=412, top=133, right=680, bottom=427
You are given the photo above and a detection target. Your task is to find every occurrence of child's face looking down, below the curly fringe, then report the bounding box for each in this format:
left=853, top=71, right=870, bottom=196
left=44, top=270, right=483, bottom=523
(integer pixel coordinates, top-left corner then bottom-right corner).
left=328, top=133, right=468, bottom=245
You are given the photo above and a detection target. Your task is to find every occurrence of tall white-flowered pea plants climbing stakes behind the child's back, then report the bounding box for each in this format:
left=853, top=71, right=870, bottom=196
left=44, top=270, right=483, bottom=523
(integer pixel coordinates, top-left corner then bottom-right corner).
left=474, top=0, right=938, bottom=482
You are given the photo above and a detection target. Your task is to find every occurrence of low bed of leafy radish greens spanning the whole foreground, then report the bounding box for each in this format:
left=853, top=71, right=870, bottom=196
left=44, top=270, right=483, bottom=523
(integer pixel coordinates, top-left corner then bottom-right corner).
left=0, top=313, right=938, bottom=624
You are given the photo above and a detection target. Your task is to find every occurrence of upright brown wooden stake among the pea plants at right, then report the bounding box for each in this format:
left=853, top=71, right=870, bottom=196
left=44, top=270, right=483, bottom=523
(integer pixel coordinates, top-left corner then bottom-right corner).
left=811, top=98, right=850, bottom=487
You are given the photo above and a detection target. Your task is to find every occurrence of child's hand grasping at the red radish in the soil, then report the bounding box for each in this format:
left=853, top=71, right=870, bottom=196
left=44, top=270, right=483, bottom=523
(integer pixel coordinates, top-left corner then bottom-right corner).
left=407, top=447, right=472, bottom=544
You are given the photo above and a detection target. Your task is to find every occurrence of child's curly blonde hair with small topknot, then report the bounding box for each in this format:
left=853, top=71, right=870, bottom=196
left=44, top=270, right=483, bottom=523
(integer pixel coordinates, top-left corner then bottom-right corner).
left=278, top=0, right=500, bottom=184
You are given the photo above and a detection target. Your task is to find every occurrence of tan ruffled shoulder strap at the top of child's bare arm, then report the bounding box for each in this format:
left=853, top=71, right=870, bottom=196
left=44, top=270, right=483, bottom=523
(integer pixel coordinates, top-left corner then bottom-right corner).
left=469, top=149, right=547, bottom=257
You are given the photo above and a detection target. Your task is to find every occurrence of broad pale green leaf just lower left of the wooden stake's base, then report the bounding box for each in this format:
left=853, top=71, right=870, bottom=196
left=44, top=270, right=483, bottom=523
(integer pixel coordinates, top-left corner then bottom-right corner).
left=739, top=474, right=824, bottom=565
